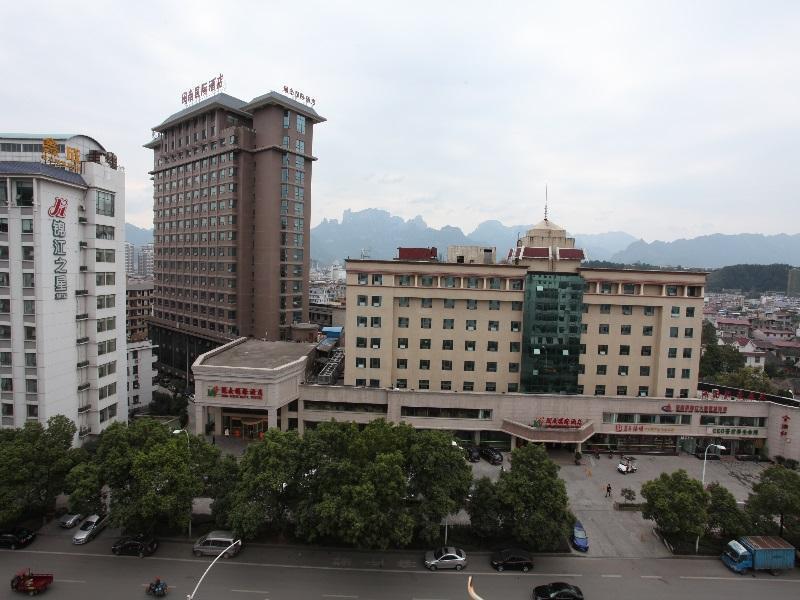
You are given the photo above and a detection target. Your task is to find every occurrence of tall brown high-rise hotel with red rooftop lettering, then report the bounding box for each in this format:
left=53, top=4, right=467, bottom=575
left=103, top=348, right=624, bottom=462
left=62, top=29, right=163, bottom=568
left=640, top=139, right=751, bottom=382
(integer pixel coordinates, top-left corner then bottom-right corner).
left=145, top=92, right=325, bottom=376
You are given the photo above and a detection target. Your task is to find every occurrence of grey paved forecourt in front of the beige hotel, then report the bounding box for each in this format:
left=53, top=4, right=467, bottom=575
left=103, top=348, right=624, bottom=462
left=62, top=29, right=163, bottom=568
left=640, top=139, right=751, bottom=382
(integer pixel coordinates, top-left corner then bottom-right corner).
left=551, top=451, right=765, bottom=558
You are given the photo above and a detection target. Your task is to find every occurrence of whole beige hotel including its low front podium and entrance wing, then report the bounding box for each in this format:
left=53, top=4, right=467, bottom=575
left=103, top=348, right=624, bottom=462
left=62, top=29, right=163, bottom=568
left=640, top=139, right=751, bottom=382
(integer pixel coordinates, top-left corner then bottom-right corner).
left=188, top=219, right=800, bottom=457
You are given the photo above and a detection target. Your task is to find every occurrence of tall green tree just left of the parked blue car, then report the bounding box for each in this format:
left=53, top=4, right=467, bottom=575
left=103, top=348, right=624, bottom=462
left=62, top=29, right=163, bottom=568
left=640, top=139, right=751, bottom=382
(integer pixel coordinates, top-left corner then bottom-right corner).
left=497, top=444, right=575, bottom=550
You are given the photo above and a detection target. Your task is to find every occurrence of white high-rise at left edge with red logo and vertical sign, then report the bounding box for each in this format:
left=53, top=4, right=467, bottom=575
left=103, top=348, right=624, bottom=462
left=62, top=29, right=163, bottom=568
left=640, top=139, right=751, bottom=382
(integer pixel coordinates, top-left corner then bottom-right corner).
left=0, top=134, right=127, bottom=439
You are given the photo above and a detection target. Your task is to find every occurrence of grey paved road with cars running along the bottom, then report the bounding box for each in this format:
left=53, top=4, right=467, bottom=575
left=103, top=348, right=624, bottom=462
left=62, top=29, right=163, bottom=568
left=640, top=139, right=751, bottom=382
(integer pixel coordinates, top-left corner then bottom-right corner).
left=0, top=533, right=800, bottom=600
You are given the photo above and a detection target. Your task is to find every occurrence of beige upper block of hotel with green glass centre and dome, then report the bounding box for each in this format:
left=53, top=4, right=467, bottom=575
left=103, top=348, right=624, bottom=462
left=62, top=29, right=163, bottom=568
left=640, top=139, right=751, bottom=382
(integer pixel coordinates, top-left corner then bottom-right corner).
left=344, top=219, right=706, bottom=398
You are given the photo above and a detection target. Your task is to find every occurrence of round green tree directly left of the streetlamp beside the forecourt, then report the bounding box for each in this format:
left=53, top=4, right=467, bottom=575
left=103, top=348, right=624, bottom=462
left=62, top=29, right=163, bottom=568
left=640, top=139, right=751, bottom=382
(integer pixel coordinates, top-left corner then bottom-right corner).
left=641, top=469, right=709, bottom=539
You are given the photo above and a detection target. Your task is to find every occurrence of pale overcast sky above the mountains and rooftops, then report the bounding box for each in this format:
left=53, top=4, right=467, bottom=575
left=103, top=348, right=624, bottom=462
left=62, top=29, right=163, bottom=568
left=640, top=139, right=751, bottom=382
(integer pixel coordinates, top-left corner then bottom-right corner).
left=6, top=0, right=800, bottom=240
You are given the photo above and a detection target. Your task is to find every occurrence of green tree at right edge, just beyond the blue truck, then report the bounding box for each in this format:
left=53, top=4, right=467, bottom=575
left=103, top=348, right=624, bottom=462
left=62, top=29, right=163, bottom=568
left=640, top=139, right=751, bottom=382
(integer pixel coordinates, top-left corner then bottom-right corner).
left=746, top=465, right=800, bottom=535
